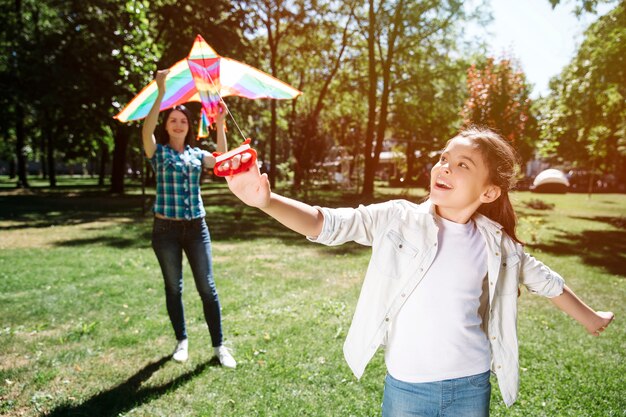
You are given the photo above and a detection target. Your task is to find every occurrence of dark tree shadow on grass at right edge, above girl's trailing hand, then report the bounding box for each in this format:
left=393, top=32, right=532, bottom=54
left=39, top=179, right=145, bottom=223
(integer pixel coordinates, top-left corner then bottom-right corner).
left=528, top=217, right=626, bottom=277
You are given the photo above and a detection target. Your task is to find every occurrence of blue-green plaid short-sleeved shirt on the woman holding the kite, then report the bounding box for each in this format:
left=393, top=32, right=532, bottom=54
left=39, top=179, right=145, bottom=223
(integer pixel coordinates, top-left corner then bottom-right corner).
left=150, top=144, right=207, bottom=220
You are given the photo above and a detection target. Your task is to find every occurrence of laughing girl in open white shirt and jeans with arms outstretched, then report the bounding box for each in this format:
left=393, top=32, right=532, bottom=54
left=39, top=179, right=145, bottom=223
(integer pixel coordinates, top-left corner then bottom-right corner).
left=216, top=128, right=613, bottom=417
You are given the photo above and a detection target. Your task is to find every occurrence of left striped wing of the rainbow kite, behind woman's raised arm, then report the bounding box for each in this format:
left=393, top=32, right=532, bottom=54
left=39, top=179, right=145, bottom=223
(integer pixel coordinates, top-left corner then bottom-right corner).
left=115, top=59, right=200, bottom=122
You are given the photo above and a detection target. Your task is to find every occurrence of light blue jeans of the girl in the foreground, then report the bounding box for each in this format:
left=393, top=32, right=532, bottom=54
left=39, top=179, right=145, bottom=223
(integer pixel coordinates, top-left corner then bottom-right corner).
left=383, top=371, right=491, bottom=417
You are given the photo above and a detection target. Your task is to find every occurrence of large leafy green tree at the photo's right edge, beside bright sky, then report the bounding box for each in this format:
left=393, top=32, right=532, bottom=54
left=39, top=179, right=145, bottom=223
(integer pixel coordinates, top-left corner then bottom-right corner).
left=540, top=2, right=626, bottom=189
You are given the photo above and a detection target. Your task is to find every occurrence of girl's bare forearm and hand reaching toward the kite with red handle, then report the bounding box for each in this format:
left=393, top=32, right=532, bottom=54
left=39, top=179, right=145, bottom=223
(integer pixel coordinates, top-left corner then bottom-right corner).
left=220, top=155, right=324, bottom=237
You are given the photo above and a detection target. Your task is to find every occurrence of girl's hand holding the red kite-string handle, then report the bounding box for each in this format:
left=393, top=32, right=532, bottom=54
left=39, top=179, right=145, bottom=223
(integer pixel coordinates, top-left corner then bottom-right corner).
left=218, top=154, right=271, bottom=209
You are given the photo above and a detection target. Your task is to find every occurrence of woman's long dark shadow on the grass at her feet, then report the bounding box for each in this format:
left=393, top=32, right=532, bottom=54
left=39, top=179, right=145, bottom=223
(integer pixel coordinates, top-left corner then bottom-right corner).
left=44, top=356, right=218, bottom=417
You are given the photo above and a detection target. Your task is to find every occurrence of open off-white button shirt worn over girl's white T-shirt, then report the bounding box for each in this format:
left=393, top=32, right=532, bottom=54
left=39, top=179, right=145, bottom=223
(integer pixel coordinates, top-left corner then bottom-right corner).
left=309, top=200, right=564, bottom=406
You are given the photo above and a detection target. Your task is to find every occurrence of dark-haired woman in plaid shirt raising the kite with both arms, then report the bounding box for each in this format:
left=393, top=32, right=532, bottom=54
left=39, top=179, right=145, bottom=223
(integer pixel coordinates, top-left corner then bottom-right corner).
left=142, top=70, right=237, bottom=368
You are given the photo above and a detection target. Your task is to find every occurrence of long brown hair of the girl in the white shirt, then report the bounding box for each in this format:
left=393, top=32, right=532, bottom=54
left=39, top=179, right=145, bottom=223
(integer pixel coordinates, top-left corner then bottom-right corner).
left=457, top=126, right=523, bottom=244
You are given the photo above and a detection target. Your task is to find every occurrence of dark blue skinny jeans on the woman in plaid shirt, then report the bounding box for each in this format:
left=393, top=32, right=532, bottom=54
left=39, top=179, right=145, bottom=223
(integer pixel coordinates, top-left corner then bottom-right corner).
left=152, top=217, right=222, bottom=347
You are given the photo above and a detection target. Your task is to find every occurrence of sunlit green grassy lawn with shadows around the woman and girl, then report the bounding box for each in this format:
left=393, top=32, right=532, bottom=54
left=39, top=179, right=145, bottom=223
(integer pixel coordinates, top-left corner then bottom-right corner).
left=0, top=178, right=626, bottom=417
